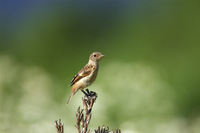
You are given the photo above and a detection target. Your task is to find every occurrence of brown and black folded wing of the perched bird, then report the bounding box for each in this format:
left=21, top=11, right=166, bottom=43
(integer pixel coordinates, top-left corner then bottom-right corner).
left=70, top=65, right=94, bottom=86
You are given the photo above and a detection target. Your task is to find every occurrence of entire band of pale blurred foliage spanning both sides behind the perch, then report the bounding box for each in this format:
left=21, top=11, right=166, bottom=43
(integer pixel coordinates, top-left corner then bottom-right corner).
left=0, top=55, right=200, bottom=133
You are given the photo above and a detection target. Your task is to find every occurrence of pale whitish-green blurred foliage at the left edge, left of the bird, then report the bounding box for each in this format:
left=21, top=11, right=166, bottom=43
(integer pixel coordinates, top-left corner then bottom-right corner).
left=0, top=55, right=55, bottom=133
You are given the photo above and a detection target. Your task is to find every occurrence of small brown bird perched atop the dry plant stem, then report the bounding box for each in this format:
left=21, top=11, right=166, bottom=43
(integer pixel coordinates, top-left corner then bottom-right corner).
left=67, top=52, right=104, bottom=104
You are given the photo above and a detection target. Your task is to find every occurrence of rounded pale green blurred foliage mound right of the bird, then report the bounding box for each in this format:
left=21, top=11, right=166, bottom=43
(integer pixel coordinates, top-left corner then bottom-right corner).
left=97, top=62, right=175, bottom=116
